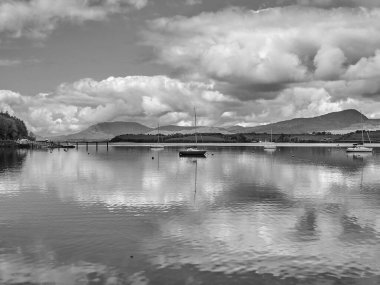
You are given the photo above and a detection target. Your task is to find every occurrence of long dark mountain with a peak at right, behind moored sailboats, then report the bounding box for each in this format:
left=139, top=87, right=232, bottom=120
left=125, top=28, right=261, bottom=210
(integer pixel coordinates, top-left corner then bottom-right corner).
left=235, top=109, right=380, bottom=134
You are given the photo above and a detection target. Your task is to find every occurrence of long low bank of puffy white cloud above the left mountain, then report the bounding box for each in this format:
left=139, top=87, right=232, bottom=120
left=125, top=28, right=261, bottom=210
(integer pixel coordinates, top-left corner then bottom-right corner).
left=0, top=76, right=234, bottom=135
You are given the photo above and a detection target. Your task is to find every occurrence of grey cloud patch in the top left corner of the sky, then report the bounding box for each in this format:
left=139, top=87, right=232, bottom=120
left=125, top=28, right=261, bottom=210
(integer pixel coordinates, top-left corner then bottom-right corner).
left=0, top=0, right=148, bottom=38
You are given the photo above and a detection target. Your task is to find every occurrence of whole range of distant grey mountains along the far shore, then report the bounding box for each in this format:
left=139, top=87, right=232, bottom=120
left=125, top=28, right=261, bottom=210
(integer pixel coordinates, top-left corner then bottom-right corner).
left=50, top=109, right=380, bottom=141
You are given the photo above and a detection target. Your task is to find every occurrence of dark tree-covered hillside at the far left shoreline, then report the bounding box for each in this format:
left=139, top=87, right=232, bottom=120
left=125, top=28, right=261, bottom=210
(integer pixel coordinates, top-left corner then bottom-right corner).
left=0, top=112, right=28, bottom=140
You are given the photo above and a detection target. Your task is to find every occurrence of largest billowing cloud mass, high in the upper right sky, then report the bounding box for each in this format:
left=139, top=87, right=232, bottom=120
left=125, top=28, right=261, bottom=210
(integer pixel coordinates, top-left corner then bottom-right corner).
left=144, top=6, right=380, bottom=100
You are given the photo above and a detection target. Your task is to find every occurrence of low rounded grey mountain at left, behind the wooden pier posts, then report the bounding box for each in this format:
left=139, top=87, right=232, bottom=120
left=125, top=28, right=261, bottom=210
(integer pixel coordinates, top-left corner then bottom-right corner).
left=50, top=122, right=152, bottom=141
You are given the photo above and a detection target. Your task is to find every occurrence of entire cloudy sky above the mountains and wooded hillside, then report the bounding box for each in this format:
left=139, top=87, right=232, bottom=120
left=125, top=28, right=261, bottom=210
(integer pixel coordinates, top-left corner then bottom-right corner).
left=0, top=0, right=380, bottom=136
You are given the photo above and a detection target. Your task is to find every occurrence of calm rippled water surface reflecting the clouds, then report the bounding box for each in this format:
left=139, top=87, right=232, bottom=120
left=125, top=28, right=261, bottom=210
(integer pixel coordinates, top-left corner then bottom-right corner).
left=0, top=146, right=380, bottom=285
